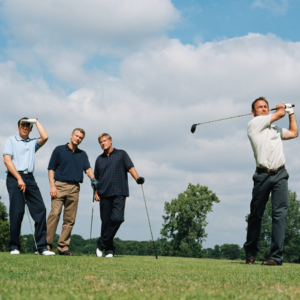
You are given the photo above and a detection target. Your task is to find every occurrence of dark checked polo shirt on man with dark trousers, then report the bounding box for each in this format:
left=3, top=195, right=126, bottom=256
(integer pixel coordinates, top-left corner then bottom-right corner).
left=94, top=148, right=134, bottom=198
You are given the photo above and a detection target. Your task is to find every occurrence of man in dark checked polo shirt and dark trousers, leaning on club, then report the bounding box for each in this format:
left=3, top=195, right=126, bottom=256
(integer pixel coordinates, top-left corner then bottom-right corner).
left=94, top=133, right=145, bottom=257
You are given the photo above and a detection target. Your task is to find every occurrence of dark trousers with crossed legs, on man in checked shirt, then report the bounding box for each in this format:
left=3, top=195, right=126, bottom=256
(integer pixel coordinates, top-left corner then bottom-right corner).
left=97, top=196, right=126, bottom=254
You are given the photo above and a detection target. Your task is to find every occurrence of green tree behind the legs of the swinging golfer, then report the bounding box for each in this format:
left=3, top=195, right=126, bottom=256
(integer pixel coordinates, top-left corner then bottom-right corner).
left=246, top=191, right=300, bottom=262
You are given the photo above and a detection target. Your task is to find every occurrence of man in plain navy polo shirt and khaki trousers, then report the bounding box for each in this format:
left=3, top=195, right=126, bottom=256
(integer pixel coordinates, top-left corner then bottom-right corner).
left=47, top=128, right=97, bottom=256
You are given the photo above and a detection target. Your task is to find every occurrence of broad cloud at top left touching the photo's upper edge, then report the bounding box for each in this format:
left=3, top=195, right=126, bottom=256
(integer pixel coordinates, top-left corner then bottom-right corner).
left=2, top=0, right=179, bottom=47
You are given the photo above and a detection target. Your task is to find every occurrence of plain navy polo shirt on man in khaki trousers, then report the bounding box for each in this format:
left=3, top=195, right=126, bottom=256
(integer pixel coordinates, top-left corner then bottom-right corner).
left=48, top=144, right=91, bottom=182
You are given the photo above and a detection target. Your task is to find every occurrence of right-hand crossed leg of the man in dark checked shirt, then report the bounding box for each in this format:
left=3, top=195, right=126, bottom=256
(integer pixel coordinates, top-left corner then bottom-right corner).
left=99, top=196, right=126, bottom=254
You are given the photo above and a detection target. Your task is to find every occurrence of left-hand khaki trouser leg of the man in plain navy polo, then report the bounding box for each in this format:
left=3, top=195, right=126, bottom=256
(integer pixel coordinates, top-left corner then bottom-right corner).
left=46, top=181, right=68, bottom=250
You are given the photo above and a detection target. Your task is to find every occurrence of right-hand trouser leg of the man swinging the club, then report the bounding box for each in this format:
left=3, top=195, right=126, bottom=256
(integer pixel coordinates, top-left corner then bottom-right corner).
left=270, top=169, right=289, bottom=265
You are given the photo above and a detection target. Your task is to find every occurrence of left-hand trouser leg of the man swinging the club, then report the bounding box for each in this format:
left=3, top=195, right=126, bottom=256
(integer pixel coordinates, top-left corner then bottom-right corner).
left=244, top=172, right=271, bottom=256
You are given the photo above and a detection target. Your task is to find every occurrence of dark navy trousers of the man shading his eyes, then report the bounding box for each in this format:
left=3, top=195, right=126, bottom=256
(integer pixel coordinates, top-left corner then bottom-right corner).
left=6, top=173, right=47, bottom=252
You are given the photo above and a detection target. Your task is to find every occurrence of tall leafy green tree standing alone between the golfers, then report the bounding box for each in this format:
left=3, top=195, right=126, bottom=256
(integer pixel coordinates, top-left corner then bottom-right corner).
left=160, top=183, right=220, bottom=257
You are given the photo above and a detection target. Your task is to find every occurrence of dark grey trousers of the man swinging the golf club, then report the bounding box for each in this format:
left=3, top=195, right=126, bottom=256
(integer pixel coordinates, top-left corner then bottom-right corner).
left=244, top=169, right=289, bottom=265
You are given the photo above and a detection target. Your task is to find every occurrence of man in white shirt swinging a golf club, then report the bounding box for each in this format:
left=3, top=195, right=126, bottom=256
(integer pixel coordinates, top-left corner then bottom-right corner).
left=244, top=97, right=298, bottom=266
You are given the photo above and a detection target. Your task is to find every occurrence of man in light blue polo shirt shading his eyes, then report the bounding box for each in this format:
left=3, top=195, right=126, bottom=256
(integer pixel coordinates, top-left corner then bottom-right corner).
left=3, top=118, right=55, bottom=255
